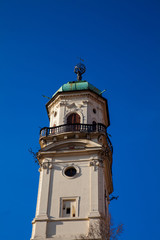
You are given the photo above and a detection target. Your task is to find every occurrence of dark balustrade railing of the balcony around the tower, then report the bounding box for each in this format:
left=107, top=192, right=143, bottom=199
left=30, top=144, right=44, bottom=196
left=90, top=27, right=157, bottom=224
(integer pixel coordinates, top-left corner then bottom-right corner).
left=40, top=123, right=113, bottom=152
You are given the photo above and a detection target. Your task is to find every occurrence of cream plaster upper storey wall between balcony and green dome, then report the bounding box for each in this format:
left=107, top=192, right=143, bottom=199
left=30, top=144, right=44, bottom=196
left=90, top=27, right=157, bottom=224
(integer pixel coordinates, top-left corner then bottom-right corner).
left=47, top=91, right=108, bottom=127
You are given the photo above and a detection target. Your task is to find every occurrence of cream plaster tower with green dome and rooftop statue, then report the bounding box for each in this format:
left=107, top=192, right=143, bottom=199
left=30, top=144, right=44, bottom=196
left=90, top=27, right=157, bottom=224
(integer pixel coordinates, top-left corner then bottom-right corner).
left=31, top=64, right=113, bottom=240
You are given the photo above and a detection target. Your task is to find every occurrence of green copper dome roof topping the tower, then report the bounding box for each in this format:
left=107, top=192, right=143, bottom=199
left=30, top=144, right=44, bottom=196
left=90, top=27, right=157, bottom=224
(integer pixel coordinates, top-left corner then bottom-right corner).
left=52, top=81, right=102, bottom=97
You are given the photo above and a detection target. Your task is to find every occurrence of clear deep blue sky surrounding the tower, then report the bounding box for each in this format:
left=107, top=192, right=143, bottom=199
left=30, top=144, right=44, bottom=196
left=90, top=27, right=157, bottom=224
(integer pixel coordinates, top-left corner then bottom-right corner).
left=0, top=0, right=160, bottom=240
